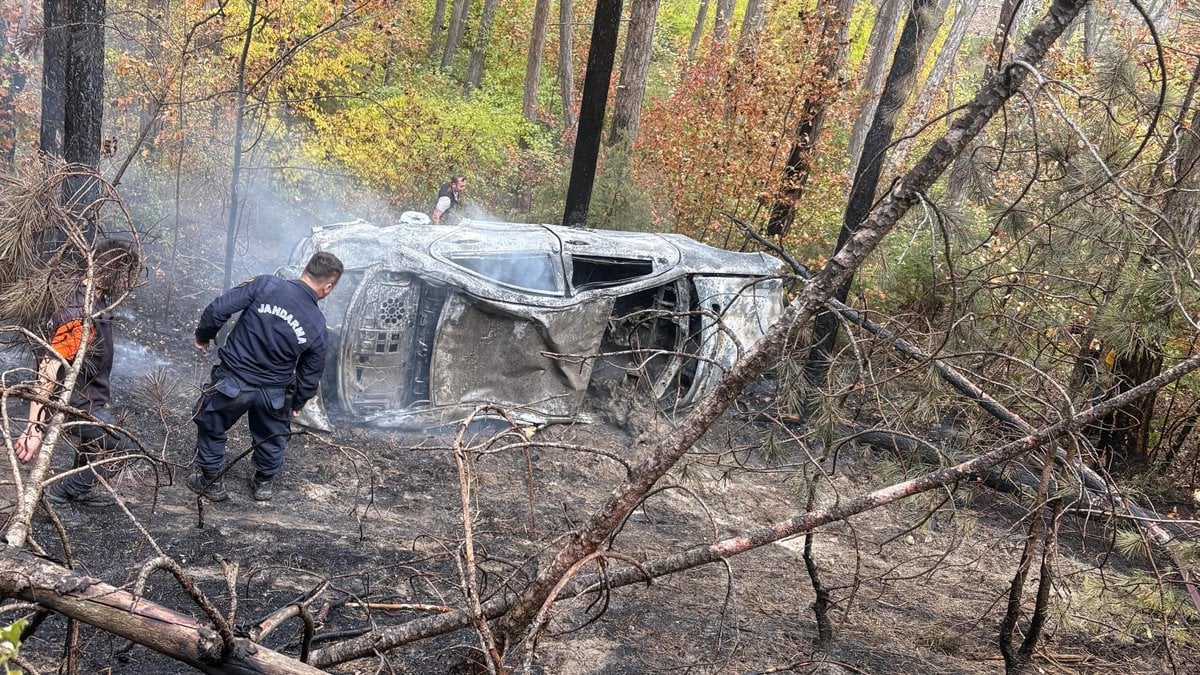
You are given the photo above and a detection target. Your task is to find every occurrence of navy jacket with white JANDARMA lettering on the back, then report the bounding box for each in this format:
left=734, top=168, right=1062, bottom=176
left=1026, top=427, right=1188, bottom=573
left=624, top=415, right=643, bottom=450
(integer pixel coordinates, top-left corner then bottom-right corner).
left=196, top=275, right=326, bottom=410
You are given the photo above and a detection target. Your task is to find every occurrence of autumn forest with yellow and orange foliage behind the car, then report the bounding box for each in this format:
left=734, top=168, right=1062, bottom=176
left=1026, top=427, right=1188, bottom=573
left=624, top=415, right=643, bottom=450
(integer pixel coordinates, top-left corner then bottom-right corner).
left=0, top=0, right=1200, bottom=669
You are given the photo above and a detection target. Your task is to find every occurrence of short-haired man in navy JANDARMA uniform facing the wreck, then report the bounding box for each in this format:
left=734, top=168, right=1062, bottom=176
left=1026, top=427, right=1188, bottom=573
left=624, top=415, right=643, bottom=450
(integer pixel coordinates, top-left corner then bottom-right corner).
left=187, top=251, right=343, bottom=502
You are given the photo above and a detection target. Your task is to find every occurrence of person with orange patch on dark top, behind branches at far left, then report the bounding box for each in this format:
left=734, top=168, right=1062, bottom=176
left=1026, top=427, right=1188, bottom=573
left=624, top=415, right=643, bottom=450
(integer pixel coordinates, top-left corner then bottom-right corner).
left=13, top=239, right=142, bottom=507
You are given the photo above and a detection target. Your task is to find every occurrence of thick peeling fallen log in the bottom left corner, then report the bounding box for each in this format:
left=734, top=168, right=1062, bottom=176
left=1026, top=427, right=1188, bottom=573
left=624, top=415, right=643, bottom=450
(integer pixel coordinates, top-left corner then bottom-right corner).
left=0, top=546, right=320, bottom=675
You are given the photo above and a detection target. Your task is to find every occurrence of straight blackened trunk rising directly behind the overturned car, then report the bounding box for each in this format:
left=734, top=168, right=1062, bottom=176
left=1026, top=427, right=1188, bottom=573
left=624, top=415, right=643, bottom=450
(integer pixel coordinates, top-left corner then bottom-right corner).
left=563, top=0, right=622, bottom=227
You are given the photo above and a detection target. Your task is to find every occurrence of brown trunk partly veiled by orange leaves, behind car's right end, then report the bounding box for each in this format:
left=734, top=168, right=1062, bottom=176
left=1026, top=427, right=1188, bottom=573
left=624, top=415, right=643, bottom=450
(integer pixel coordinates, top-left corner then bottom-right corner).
left=767, top=0, right=854, bottom=237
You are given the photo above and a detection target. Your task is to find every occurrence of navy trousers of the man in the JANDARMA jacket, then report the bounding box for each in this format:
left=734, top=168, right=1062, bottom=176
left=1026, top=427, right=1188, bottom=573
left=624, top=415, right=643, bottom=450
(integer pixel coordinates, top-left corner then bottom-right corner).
left=193, top=365, right=292, bottom=478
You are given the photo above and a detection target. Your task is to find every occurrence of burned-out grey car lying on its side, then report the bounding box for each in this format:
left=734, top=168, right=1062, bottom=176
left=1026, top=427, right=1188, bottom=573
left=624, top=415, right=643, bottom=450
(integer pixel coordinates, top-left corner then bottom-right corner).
left=281, top=214, right=782, bottom=429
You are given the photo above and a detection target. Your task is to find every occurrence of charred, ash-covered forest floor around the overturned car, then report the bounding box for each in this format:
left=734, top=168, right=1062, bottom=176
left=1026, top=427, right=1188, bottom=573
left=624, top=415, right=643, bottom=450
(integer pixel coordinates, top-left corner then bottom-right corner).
left=6, top=239, right=1198, bottom=674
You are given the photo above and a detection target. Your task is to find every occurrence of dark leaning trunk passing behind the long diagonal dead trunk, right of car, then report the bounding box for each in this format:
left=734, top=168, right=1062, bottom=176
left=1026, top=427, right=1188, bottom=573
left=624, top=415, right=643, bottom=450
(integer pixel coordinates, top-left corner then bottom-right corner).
left=804, top=0, right=944, bottom=388
